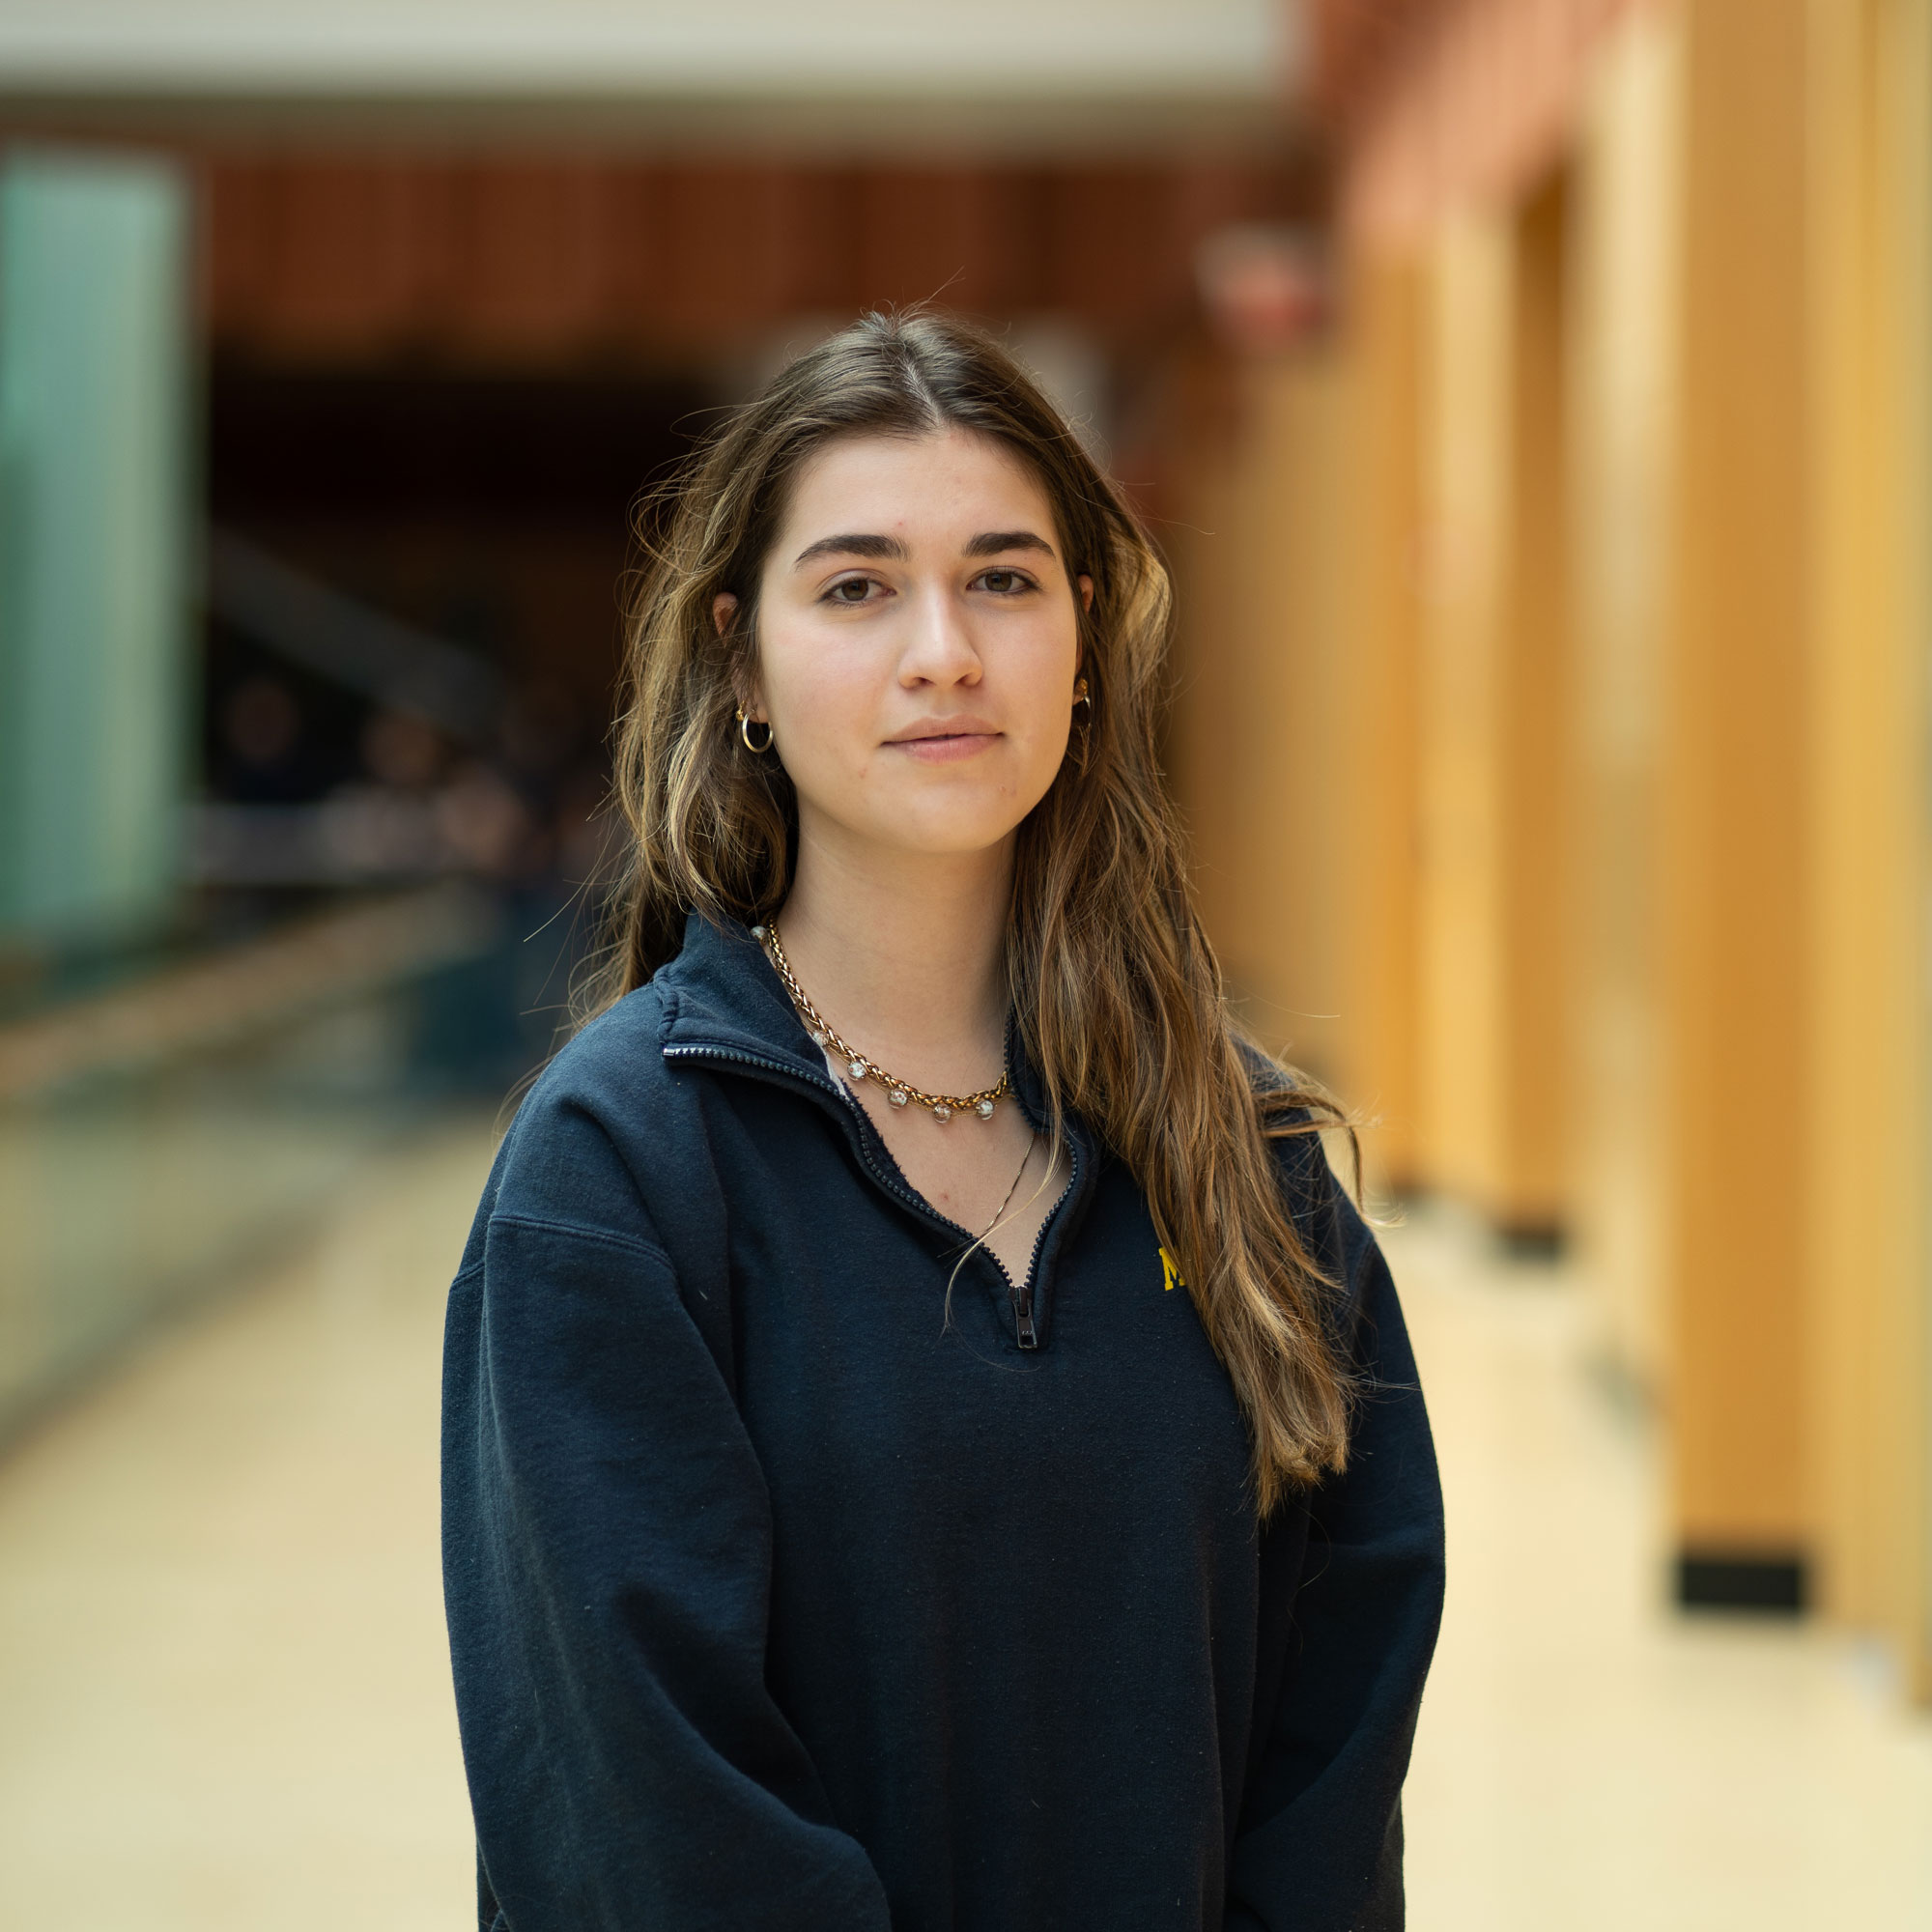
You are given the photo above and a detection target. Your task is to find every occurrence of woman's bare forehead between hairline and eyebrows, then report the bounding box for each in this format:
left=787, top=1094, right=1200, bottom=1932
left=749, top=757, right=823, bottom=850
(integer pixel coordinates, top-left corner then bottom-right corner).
left=781, top=429, right=1055, bottom=547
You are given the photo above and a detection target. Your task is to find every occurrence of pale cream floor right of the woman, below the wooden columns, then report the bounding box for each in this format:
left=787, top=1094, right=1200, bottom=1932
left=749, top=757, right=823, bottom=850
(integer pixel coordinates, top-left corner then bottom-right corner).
left=1385, top=1217, right=1932, bottom=1932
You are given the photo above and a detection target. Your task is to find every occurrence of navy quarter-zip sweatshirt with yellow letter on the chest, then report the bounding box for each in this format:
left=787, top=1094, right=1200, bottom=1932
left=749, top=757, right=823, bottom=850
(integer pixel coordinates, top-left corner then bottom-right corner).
left=444, top=918, right=1443, bottom=1932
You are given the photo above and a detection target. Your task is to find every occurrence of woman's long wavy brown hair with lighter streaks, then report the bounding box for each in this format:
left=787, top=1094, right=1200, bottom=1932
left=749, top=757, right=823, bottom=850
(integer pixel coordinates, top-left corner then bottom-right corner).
left=583, top=311, right=1350, bottom=1515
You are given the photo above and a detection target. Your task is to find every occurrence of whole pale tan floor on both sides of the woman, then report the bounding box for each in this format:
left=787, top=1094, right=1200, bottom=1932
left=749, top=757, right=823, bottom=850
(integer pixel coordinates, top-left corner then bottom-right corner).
left=0, top=1126, right=1932, bottom=1932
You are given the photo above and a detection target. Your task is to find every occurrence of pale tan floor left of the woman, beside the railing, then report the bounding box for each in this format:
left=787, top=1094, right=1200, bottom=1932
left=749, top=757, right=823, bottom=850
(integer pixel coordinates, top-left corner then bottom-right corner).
left=0, top=1126, right=489, bottom=1932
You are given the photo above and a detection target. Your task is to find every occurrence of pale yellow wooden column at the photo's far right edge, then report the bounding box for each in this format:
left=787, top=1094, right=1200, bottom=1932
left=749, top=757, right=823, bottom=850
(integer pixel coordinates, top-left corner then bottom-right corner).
left=1803, top=0, right=1932, bottom=1696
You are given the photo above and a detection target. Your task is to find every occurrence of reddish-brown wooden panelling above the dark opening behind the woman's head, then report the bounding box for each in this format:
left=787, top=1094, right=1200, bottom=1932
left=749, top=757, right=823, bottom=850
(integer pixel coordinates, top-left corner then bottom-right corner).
left=201, top=153, right=1308, bottom=365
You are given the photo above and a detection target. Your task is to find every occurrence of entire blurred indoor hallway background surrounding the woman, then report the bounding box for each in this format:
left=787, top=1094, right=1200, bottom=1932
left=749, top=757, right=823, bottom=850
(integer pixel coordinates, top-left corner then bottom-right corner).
left=0, top=0, right=1932, bottom=1932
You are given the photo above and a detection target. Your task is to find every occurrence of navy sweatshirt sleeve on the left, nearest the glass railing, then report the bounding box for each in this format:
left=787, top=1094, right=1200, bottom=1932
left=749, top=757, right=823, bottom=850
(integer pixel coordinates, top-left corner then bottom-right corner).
left=442, top=1122, right=889, bottom=1932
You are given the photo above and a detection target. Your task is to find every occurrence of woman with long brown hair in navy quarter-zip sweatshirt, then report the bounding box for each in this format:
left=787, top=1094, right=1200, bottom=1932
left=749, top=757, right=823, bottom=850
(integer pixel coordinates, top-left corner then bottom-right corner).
left=444, top=315, right=1441, bottom=1932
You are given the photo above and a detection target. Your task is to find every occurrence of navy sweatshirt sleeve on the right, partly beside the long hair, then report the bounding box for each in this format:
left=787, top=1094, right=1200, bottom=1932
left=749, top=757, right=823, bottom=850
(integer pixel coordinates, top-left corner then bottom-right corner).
left=1225, top=1142, right=1443, bottom=1932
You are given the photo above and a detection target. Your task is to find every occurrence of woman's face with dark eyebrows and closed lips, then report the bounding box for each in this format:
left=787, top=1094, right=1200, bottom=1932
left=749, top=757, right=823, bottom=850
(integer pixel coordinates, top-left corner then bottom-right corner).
left=715, top=429, right=1092, bottom=873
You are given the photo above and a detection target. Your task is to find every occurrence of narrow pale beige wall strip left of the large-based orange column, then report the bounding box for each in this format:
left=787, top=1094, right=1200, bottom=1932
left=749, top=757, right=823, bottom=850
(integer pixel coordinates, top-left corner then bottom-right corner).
left=1569, top=10, right=1683, bottom=1391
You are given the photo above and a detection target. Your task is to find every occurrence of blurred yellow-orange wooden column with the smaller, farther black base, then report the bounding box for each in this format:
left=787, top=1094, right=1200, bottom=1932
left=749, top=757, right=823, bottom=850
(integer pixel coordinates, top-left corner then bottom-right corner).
left=1418, top=174, right=1575, bottom=1246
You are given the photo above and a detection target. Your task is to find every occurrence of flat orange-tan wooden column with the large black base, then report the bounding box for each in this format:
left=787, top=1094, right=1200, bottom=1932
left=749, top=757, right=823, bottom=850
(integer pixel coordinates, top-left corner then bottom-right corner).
left=1658, top=0, right=1816, bottom=1602
